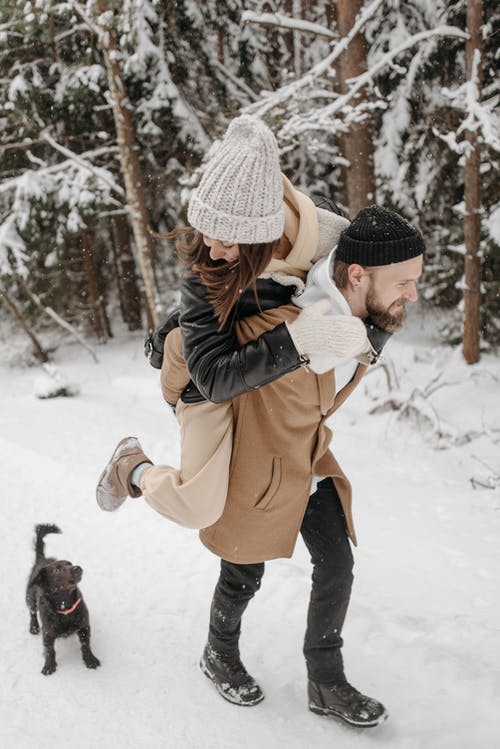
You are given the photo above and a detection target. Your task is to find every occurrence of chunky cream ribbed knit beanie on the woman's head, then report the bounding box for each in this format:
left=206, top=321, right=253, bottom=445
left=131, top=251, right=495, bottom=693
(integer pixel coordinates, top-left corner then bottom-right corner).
left=188, top=114, right=285, bottom=244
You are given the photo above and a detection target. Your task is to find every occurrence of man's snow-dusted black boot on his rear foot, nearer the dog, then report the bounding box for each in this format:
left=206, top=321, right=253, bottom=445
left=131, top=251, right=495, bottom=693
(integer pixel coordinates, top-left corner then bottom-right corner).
left=200, top=644, right=264, bottom=706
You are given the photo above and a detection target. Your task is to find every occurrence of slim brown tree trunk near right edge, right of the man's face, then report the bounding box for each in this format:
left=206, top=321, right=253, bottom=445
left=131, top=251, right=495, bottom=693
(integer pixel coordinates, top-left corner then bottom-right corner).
left=462, top=0, right=483, bottom=364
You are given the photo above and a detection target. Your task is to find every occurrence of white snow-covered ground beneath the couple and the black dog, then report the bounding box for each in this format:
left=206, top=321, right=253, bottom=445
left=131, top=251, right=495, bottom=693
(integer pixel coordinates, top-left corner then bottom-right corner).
left=0, top=306, right=500, bottom=749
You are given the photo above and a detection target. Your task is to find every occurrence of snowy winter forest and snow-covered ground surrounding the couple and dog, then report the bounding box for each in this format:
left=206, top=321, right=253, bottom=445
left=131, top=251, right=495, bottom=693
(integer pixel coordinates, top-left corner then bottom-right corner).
left=0, top=0, right=500, bottom=749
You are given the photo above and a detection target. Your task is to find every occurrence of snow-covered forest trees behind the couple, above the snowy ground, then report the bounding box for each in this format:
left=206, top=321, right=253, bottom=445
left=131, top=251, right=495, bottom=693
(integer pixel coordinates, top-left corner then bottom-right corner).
left=0, top=0, right=500, bottom=362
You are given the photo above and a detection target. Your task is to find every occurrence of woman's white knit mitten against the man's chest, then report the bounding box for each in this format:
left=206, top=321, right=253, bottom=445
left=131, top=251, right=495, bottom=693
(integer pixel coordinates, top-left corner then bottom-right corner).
left=287, top=299, right=371, bottom=374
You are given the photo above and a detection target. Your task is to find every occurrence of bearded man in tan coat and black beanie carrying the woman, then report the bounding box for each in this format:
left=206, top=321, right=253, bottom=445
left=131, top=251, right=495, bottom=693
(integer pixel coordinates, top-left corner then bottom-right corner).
left=195, top=206, right=424, bottom=726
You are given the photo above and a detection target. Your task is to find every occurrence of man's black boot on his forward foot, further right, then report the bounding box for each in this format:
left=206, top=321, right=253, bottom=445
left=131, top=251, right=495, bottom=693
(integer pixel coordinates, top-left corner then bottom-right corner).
left=308, top=679, right=388, bottom=728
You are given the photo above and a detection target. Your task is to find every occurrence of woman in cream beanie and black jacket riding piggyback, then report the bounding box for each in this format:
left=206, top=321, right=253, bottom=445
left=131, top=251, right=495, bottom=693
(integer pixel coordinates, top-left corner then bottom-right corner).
left=98, top=116, right=366, bottom=528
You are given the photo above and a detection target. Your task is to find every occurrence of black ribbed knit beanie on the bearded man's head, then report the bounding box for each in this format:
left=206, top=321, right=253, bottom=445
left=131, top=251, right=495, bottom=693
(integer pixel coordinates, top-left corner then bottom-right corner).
left=335, top=205, right=425, bottom=266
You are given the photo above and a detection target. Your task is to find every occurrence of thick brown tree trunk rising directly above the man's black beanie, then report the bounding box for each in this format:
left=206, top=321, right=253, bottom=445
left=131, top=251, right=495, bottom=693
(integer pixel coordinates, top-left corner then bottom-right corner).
left=337, top=0, right=375, bottom=218
